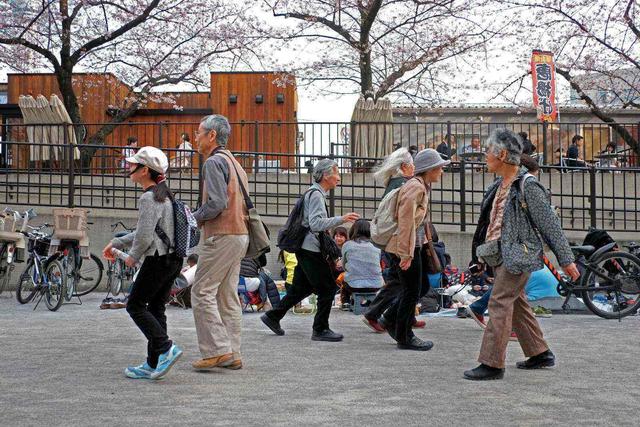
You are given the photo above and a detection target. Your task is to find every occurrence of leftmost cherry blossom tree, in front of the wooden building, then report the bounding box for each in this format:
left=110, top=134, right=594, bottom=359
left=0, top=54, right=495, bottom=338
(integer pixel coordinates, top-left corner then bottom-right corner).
left=0, top=0, right=256, bottom=162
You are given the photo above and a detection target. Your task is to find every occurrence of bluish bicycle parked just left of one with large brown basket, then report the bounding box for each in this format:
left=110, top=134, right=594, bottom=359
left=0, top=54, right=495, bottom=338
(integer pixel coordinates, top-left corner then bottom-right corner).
left=16, top=224, right=66, bottom=311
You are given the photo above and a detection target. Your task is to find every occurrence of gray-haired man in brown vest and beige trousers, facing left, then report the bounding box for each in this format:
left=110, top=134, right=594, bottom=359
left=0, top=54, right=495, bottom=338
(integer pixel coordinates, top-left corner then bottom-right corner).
left=191, top=115, right=249, bottom=370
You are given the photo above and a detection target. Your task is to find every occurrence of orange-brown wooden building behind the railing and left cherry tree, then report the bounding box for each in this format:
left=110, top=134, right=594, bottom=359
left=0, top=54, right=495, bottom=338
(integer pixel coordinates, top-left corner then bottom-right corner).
left=0, top=72, right=297, bottom=170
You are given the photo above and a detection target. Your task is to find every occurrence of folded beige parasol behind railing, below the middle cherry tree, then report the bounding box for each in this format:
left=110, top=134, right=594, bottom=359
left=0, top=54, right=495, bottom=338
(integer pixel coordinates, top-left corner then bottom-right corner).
left=351, top=96, right=393, bottom=158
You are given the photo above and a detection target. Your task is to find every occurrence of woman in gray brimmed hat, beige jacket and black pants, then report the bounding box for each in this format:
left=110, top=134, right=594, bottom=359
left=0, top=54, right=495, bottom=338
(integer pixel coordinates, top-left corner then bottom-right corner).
left=384, top=148, right=451, bottom=351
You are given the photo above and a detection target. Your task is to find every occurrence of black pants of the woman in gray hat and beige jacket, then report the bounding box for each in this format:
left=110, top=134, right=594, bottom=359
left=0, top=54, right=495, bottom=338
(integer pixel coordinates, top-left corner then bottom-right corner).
left=384, top=248, right=422, bottom=344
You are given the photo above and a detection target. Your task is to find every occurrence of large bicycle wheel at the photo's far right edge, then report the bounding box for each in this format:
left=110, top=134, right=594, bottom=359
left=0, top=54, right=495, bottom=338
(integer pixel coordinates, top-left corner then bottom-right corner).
left=580, top=252, right=640, bottom=319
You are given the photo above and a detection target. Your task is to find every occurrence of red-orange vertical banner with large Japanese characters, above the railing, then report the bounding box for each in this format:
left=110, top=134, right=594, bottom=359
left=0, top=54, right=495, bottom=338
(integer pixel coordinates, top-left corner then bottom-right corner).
left=531, top=50, right=558, bottom=122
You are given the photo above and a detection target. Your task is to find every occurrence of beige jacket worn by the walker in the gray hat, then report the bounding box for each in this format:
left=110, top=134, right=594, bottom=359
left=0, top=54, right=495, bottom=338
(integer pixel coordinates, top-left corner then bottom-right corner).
left=385, top=177, right=429, bottom=260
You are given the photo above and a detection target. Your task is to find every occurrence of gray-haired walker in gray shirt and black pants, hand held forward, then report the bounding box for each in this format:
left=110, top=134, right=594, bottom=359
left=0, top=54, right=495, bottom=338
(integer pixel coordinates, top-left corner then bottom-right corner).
left=260, top=159, right=360, bottom=341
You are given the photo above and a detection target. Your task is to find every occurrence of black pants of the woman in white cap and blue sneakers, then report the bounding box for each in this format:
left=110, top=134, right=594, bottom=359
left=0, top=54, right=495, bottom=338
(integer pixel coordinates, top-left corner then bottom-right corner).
left=127, top=254, right=182, bottom=368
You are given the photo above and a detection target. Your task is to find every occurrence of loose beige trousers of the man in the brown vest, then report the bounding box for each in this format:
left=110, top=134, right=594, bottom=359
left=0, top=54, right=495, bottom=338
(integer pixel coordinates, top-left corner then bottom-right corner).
left=191, top=235, right=249, bottom=359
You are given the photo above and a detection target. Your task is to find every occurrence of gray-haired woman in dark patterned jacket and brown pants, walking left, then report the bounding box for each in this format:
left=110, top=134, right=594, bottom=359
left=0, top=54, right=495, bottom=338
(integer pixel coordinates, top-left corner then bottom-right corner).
left=464, top=129, right=580, bottom=380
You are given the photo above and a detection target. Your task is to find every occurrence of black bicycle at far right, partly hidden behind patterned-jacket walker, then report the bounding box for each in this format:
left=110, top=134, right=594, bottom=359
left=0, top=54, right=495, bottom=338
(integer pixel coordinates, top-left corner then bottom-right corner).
left=542, top=243, right=640, bottom=320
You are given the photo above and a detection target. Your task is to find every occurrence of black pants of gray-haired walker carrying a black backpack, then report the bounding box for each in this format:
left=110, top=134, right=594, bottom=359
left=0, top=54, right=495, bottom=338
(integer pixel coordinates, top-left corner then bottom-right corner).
left=266, top=249, right=337, bottom=332
